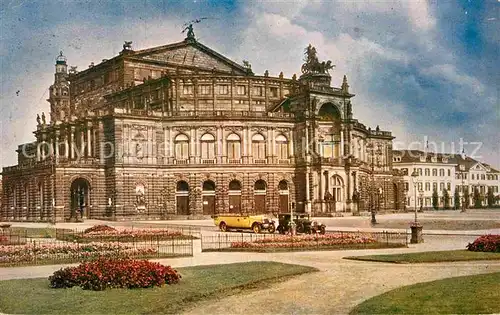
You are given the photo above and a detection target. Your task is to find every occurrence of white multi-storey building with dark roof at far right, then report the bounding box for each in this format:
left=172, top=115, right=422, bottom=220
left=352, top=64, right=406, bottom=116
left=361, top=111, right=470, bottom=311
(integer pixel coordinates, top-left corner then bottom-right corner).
left=393, top=150, right=500, bottom=209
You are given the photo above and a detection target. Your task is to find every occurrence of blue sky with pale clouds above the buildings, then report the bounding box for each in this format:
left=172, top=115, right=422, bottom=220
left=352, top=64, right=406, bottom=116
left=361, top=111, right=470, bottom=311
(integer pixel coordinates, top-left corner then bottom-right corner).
left=0, top=0, right=500, bottom=167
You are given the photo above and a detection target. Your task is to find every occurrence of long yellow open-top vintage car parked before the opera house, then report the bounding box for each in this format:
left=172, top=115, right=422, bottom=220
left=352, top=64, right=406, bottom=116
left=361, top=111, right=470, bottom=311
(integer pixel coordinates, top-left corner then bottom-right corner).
left=213, top=214, right=276, bottom=233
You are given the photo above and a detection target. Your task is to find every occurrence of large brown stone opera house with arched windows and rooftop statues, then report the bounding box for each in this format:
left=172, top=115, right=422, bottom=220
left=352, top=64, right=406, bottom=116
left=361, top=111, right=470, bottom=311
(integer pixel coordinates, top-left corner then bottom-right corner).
left=1, top=29, right=404, bottom=221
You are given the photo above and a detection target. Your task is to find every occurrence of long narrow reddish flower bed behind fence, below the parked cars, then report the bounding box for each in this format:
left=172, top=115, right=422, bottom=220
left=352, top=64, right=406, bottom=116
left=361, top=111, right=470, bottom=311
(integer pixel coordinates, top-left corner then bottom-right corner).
left=231, top=233, right=376, bottom=248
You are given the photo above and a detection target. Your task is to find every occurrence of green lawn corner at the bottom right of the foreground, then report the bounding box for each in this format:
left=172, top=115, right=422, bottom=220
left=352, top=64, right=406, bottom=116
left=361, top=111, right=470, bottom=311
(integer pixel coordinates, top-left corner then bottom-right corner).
left=350, top=272, right=500, bottom=314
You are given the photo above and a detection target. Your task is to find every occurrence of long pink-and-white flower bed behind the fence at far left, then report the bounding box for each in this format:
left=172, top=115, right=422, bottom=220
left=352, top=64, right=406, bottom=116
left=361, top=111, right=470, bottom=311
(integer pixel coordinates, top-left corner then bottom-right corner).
left=0, top=243, right=157, bottom=265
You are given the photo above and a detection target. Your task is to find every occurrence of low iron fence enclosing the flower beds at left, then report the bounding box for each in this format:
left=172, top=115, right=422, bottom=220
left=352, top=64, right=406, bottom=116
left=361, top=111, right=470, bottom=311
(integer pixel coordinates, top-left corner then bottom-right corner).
left=0, top=229, right=194, bottom=267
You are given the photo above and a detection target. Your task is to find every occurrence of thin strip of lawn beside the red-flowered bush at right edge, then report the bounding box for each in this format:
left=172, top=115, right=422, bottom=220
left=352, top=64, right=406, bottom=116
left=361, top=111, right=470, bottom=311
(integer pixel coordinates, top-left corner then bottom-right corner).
left=344, top=249, right=500, bottom=264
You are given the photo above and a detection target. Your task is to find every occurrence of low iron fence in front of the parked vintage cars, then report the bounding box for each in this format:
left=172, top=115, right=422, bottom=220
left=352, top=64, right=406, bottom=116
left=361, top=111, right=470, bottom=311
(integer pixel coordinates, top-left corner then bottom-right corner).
left=201, top=231, right=408, bottom=252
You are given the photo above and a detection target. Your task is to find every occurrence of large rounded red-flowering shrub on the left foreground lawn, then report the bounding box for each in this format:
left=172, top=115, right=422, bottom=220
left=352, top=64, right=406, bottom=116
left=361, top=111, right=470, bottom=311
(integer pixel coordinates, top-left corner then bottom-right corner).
left=49, top=258, right=181, bottom=291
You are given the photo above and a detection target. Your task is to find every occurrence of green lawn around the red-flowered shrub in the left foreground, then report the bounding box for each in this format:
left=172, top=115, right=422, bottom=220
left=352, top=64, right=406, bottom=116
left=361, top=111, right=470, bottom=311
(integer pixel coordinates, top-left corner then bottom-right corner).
left=0, top=262, right=317, bottom=314
